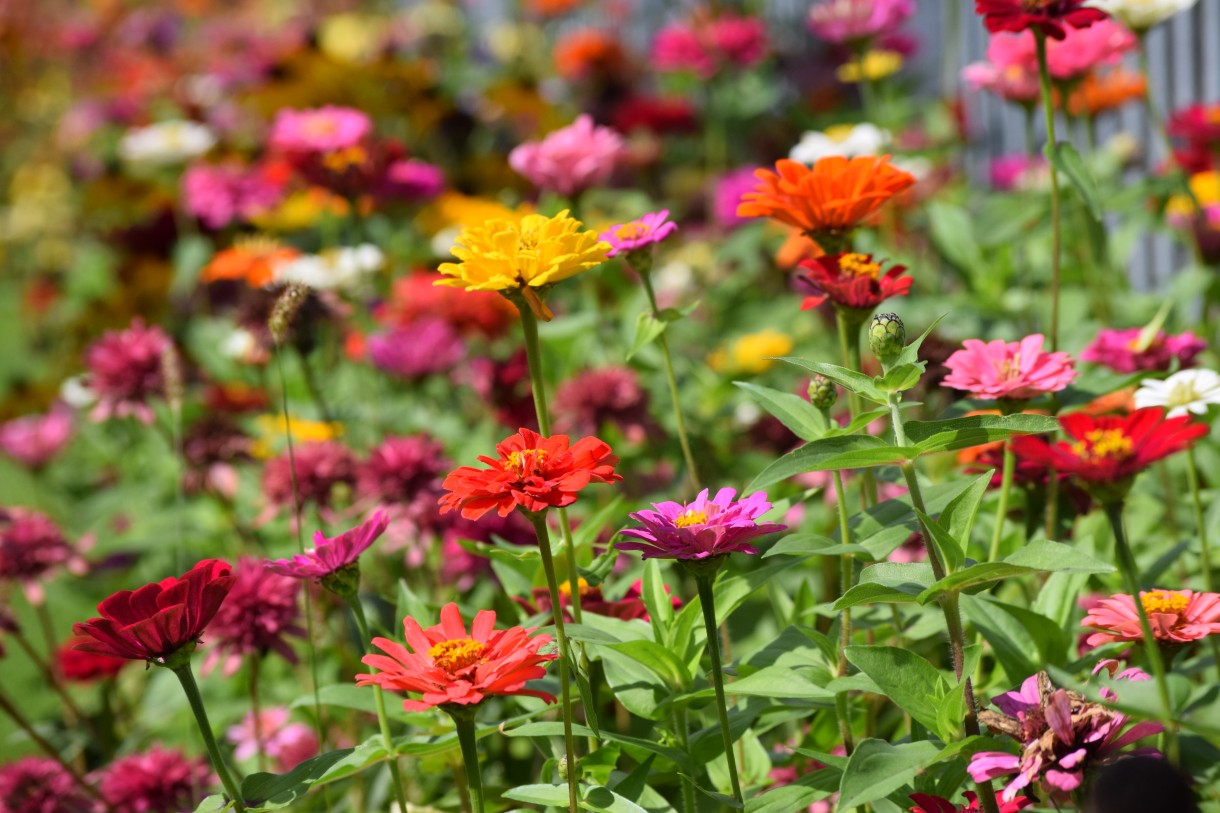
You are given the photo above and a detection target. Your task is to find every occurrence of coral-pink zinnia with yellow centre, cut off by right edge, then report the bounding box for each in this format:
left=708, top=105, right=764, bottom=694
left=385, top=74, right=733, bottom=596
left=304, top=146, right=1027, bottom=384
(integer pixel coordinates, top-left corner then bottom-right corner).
left=1081, top=590, right=1220, bottom=647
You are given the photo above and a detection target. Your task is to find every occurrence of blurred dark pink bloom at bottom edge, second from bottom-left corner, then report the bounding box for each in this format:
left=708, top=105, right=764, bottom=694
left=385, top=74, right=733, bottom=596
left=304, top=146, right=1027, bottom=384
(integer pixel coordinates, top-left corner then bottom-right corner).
left=99, top=745, right=215, bottom=813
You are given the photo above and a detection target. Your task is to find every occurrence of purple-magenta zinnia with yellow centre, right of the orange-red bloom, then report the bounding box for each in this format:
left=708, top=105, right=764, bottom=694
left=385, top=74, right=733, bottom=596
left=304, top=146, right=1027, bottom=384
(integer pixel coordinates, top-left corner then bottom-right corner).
left=615, top=488, right=787, bottom=559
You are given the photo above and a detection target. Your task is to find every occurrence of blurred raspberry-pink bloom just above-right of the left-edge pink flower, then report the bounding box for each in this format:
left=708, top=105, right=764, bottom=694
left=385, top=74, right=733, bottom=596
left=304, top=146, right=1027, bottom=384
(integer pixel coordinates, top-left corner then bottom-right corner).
left=85, top=319, right=171, bottom=424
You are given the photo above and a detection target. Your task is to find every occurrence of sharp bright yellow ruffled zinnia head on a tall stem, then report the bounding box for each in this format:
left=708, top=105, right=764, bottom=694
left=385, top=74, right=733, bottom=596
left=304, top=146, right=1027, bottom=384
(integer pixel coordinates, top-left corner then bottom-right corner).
left=436, top=209, right=611, bottom=320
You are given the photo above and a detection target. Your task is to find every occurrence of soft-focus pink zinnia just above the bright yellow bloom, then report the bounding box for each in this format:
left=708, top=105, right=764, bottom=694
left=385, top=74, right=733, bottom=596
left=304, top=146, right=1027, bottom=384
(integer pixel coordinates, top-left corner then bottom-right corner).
left=509, top=115, right=623, bottom=195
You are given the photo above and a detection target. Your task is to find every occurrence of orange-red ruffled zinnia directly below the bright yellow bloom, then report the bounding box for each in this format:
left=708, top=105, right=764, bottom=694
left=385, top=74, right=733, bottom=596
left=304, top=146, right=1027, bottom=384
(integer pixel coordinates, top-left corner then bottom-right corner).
left=440, top=428, right=622, bottom=519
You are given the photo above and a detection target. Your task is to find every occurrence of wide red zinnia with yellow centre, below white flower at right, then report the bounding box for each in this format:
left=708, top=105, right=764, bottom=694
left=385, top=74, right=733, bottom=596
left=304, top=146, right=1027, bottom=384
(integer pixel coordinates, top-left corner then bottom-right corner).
left=1013, top=407, right=1208, bottom=483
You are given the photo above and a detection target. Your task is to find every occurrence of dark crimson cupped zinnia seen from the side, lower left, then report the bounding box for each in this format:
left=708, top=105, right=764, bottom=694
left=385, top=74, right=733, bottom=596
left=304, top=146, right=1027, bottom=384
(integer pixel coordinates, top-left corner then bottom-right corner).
left=72, top=559, right=234, bottom=665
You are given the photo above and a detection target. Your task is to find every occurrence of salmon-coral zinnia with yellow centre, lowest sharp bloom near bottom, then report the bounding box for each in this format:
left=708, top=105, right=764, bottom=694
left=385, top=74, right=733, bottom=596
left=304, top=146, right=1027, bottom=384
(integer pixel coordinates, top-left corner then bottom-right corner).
left=356, top=603, right=559, bottom=712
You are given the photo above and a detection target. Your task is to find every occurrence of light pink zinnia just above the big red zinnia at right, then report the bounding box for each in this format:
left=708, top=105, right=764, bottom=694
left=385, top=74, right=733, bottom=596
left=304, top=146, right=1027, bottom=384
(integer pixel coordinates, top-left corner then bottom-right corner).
left=942, top=333, right=1077, bottom=399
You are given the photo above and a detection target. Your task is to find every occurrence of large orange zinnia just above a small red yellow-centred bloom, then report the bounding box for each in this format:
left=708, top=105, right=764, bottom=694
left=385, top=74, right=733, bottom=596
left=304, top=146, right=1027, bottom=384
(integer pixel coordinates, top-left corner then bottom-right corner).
left=737, top=155, right=915, bottom=239
